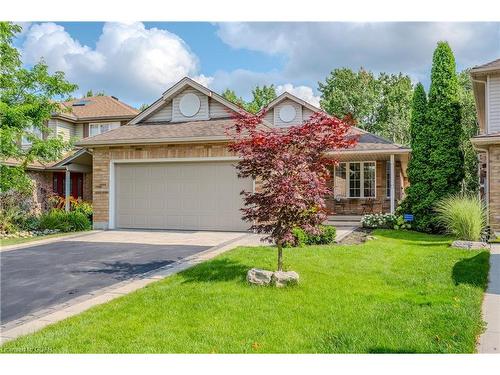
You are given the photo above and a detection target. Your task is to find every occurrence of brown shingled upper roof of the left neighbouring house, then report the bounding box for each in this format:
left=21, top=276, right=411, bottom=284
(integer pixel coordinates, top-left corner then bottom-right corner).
left=58, top=96, right=139, bottom=121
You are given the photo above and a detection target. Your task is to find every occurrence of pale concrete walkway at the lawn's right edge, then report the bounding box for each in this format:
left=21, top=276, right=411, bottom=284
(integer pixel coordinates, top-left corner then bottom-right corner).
left=477, top=244, right=500, bottom=354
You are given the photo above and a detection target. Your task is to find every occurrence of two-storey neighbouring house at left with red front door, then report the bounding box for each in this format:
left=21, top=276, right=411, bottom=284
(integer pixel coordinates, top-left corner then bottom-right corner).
left=2, top=96, right=139, bottom=214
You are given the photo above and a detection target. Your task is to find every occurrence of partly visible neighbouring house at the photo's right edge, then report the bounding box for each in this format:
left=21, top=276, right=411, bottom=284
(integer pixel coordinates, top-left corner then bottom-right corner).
left=470, top=59, right=500, bottom=236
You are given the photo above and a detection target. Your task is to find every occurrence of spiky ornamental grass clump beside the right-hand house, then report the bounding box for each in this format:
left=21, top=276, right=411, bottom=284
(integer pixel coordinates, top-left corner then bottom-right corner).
left=436, top=194, right=486, bottom=241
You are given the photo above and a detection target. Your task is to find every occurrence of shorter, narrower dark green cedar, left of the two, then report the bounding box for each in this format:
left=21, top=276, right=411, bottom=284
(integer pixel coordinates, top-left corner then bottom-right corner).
left=400, top=83, right=433, bottom=230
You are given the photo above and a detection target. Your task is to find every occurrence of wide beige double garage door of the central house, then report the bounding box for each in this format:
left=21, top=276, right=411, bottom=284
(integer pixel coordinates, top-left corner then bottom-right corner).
left=115, top=162, right=252, bottom=231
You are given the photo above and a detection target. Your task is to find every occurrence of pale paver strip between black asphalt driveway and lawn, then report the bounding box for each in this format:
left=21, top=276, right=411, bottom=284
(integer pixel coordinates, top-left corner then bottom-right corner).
left=0, top=233, right=261, bottom=345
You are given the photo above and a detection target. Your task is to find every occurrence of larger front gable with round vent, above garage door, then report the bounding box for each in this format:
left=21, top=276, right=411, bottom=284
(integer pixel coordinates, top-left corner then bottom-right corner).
left=130, top=77, right=242, bottom=125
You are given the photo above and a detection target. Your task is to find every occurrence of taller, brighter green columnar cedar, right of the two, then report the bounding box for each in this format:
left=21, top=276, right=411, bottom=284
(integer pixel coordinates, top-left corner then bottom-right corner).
left=421, top=42, right=464, bottom=231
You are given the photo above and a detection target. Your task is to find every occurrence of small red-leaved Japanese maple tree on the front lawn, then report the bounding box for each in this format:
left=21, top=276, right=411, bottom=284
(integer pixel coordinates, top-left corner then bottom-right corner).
left=229, top=113, right=357, bottom=271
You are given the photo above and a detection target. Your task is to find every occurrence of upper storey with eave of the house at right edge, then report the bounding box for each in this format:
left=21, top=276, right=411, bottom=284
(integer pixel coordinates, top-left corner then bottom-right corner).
left=470, top=59, right=500, bottom=135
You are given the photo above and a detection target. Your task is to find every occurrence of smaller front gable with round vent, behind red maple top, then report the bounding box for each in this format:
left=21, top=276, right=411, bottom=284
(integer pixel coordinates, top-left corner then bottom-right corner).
left=264, top=92, right=321, bottom=127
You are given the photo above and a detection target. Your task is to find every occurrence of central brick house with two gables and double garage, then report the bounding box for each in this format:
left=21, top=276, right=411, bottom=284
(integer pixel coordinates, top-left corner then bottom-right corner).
left=75, top=78, right=410, bottom=231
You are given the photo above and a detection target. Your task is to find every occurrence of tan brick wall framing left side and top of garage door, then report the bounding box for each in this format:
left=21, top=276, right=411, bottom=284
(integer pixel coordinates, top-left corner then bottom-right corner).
left=92, top=144, right=231, bottom=229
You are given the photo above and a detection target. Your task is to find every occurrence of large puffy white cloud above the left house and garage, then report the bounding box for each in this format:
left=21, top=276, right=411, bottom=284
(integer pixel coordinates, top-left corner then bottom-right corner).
left=23, top=22, right=207, bottom=104
